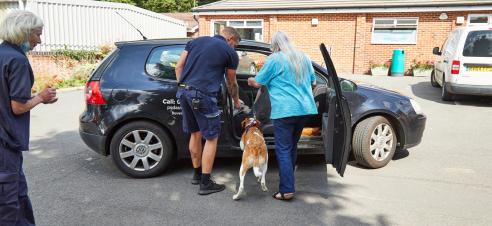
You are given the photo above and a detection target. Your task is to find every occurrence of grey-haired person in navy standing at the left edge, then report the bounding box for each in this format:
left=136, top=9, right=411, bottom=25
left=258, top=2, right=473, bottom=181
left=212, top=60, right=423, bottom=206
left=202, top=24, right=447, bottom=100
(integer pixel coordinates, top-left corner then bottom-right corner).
left=0, top=10, right=57, bottom=226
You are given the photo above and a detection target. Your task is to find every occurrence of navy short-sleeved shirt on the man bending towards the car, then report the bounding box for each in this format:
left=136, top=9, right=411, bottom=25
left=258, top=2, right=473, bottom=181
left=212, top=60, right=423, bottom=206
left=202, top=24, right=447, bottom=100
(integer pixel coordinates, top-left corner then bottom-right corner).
left=179, top=35, right=239, bottom=93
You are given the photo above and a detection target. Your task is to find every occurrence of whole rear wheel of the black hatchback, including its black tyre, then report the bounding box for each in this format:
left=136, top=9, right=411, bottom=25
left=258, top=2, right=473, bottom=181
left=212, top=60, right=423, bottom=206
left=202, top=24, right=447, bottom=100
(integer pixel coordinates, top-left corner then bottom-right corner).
left=110, top=121, right=174, bottom=178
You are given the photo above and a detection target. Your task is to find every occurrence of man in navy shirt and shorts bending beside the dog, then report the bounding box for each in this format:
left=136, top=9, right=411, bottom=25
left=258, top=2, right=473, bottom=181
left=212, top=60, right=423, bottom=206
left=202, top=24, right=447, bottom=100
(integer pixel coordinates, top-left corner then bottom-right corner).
left=176, top=27, right=241, bottom=195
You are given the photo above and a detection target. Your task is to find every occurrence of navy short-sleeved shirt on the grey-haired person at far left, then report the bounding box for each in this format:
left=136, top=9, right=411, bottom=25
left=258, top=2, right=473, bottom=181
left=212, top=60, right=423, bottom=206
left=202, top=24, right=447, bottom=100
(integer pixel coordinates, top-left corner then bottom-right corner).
left=0, top=42, right=34, bottom=151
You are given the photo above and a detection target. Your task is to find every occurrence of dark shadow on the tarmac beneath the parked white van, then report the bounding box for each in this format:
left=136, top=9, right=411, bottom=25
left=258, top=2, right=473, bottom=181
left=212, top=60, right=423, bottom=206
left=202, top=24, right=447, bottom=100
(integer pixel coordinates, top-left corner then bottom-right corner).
left=411, top=82, right=492, bottom=107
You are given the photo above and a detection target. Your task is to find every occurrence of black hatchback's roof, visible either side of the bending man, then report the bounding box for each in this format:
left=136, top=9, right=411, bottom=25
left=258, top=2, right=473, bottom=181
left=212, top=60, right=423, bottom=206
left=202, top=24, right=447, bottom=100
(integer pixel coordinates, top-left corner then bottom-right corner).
left=115, top=38, right=270, bottom=49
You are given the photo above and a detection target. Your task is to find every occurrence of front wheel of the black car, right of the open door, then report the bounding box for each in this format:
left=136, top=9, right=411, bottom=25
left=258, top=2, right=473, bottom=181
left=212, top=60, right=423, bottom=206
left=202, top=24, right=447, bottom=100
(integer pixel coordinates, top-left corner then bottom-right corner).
left=352, top=116, right=397, bottom=169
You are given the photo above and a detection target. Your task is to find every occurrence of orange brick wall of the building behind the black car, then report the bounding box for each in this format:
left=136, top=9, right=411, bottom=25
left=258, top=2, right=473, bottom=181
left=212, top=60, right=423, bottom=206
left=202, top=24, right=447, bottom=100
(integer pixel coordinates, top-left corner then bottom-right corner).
left=199, top=11, right=492, bottom=74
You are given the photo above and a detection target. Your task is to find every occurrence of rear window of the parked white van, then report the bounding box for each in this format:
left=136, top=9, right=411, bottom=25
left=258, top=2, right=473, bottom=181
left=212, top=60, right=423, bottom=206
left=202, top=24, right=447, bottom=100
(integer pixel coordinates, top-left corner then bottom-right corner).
left=463, top=30, right=492, bottom=57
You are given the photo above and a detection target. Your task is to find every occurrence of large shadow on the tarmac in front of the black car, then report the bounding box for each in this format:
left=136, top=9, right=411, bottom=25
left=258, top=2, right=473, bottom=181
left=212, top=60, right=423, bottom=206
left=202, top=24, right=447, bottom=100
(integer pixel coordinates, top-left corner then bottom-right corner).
left=26, top=131, right=391, bottom=225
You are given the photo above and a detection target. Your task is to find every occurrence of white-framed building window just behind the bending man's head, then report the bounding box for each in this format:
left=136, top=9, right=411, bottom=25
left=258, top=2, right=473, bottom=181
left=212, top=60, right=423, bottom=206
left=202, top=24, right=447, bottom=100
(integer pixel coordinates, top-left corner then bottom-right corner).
left=212, top=20, right=263, bottom=41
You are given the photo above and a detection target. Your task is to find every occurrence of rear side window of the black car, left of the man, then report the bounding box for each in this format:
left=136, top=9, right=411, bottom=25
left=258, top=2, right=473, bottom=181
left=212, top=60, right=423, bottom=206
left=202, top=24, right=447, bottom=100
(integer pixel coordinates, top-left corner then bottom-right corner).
left=145, top=45, right=184, bottom=80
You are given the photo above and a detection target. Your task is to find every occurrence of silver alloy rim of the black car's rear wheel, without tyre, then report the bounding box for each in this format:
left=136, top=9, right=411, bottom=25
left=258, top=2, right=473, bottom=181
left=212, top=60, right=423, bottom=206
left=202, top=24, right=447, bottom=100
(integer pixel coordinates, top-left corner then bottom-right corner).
left=119, top=130, right=163, bottom=171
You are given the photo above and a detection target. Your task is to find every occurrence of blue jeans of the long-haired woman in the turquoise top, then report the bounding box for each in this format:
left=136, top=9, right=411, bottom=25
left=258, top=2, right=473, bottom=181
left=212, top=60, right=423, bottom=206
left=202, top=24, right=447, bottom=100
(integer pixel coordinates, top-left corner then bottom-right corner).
left=273, top=116, right=308, bottom=193
